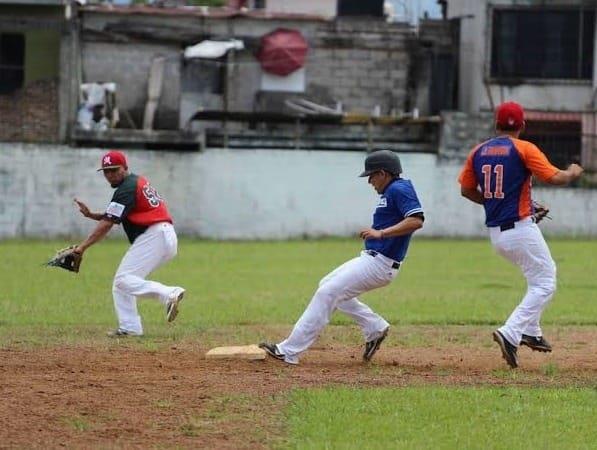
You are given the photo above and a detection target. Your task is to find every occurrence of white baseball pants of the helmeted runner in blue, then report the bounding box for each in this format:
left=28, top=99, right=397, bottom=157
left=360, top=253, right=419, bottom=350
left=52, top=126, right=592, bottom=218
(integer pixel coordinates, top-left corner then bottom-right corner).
left=277, top=251, right=398, bottom=364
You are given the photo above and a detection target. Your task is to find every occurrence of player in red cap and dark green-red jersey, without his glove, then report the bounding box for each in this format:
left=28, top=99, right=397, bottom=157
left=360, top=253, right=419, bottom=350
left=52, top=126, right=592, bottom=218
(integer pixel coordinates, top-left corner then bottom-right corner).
left=75, top=150, right=185, bottom=336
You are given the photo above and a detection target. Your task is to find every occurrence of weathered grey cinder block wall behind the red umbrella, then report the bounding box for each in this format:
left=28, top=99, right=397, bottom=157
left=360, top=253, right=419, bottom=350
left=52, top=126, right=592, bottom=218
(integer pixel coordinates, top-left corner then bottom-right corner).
left=82, top=10, right=416, bottom=128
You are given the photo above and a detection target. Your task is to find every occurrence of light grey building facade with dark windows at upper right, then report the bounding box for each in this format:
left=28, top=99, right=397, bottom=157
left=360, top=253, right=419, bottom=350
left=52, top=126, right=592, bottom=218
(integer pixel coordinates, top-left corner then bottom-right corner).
left=447, top=0, right=597, bottom=182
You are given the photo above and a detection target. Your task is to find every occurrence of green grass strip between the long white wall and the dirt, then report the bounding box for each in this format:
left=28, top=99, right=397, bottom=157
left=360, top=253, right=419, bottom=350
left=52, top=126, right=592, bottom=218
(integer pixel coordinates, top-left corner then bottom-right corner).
left=0, top=239, right=597, bottom=333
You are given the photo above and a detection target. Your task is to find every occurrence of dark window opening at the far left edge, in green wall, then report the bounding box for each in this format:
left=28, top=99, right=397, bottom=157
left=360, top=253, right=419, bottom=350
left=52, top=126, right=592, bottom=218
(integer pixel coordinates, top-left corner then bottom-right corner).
left=0, top=33, right=25, bottom=95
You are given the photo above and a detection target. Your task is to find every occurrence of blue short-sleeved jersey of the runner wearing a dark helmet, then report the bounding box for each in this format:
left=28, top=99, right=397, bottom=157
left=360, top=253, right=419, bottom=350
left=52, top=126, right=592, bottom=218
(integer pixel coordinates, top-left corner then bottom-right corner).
left=365, top=178, right=423, bottom=261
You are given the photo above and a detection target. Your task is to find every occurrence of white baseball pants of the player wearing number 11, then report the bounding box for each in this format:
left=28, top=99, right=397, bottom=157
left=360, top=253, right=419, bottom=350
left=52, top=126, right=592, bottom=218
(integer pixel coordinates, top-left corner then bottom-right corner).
left=489, top=217, right=556, bottom=346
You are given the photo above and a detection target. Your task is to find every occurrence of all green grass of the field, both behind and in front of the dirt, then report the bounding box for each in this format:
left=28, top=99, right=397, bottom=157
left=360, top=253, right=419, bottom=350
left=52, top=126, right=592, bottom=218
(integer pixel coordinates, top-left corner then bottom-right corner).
left=0, top=239, right=597, bottom=449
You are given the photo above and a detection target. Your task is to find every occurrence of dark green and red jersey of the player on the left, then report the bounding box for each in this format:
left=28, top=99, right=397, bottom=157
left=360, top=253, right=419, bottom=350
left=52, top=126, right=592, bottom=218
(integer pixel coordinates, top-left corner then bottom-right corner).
left=104, top=173, right=172, bottom=244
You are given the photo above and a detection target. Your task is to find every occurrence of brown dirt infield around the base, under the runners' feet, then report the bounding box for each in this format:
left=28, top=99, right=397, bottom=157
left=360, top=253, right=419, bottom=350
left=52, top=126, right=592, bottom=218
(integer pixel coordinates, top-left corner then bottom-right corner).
left=0, top=328, right=597, bottom=449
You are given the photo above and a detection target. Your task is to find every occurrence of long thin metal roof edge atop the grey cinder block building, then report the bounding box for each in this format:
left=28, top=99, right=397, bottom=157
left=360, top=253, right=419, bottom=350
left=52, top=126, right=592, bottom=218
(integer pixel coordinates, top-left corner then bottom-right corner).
left=80, top=4, right=326, bottom=21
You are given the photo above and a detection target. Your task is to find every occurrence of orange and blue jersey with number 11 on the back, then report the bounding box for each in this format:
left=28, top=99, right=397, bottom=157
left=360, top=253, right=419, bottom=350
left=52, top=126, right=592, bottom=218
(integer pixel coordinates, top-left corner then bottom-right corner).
left=458, top=136, right=559, bottom=227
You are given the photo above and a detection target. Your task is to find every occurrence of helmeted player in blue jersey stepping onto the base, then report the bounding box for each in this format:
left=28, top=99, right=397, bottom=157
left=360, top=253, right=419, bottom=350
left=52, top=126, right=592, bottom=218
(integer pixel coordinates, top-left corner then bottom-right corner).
left=259, top=150, right=424, bottom=364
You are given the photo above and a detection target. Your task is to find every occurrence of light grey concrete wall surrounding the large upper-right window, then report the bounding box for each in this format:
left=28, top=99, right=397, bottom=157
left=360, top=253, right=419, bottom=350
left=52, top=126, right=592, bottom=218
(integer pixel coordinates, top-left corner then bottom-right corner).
left=448, top=0, right=597, bottom=113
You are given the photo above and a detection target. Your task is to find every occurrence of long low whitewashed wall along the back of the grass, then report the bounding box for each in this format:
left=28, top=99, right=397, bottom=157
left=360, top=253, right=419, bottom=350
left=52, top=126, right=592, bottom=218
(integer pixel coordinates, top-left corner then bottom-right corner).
left=0, top=143, right=597, bottom=239
